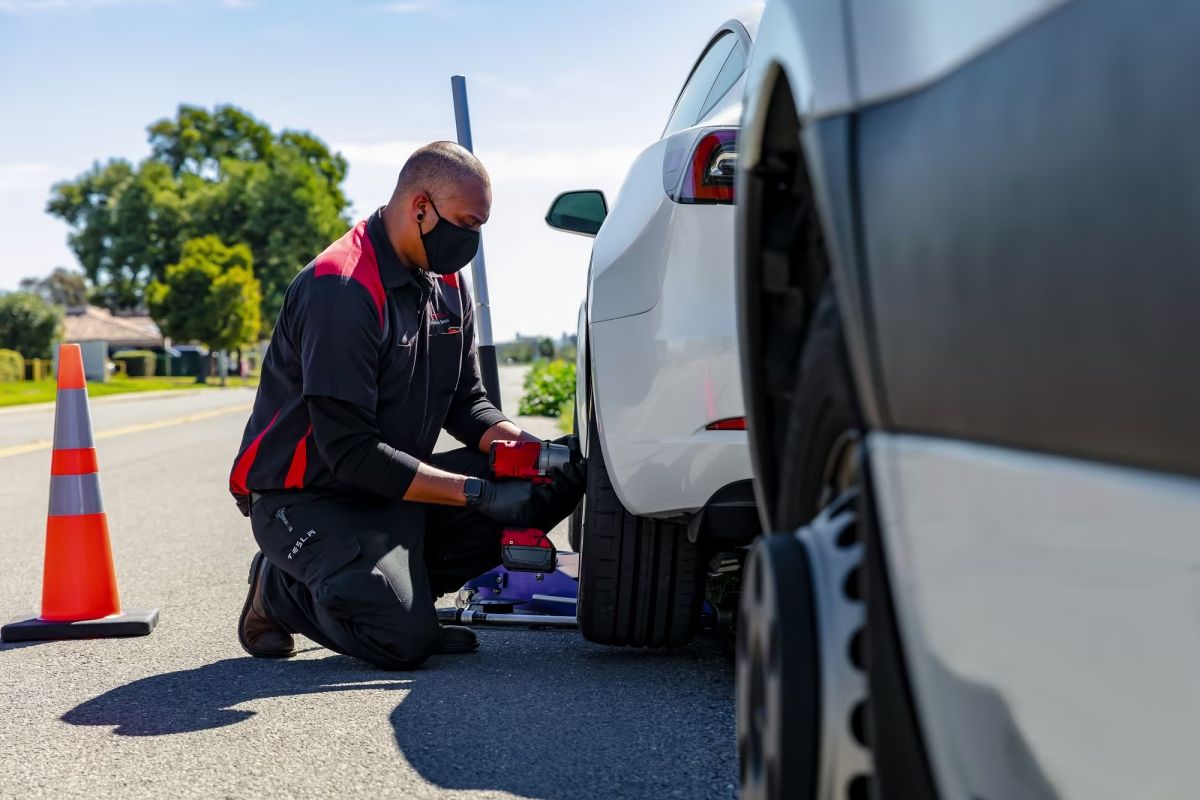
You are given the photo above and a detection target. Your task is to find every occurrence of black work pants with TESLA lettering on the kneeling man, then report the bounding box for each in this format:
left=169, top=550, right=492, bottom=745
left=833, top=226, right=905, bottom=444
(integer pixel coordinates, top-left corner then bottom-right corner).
left=250, top=449, right=560, bottom=669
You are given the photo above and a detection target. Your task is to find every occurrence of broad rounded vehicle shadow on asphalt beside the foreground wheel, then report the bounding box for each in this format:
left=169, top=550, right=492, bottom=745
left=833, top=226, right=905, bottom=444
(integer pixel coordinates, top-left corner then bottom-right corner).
left=391, top=630, right=738, bottom=800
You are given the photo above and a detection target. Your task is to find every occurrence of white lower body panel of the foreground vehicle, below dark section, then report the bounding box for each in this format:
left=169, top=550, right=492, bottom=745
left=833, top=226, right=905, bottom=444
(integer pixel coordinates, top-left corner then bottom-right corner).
left=869, top=433, right=1200, bottom=800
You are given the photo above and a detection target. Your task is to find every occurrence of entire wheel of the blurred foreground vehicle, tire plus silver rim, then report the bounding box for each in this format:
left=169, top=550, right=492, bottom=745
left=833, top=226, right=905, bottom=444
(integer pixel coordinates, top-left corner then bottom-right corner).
left=737, top=288, right=871, bottom=800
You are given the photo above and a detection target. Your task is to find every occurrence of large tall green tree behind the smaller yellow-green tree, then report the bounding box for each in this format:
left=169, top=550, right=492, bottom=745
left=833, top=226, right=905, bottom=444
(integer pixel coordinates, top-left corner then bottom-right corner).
left=47, top=106, right=349, bottom=333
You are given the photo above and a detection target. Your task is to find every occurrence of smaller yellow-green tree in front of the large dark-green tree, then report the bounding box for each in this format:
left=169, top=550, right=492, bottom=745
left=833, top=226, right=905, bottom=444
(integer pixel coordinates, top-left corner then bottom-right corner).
left=146, top=236, right=262, bottom=385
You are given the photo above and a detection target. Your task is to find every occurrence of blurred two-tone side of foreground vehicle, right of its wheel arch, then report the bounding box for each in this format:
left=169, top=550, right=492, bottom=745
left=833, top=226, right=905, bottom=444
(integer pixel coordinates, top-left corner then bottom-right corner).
left=850, top=0, right=1200, bottom=798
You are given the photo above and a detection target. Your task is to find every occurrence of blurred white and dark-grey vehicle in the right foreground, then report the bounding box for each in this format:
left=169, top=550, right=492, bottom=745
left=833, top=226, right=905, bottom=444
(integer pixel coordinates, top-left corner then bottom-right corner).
left=737, top=0, right=1200, bottom=800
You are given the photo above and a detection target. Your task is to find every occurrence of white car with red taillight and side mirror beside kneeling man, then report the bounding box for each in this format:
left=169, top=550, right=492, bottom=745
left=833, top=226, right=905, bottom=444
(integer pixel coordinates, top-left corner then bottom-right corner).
left=546, top=8, right=761, bottom=646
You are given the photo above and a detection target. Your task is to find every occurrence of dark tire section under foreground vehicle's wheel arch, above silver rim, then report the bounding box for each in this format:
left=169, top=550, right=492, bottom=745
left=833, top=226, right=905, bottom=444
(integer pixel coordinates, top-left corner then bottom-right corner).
left=770, top=284, right=863, bottom=530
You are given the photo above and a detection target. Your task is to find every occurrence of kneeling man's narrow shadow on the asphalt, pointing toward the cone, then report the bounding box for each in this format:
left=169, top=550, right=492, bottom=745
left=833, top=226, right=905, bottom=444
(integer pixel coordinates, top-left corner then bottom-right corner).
left=62, top=656, right=410, bottom=736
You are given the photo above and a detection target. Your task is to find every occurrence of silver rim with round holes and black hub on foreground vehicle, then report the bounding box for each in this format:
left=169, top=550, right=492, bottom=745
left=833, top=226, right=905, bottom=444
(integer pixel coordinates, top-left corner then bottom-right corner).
left=737, top=492, right=871, bottom=800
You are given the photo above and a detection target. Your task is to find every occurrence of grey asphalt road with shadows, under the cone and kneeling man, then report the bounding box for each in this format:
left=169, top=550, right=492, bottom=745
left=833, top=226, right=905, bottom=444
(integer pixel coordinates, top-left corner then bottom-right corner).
left=0, top=368, right=737, bottom=799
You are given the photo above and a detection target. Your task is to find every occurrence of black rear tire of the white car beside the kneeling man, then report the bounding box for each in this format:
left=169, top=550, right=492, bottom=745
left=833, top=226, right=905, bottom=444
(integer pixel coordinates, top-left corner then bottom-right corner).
left=578, top=402, right=706, bottom=648
